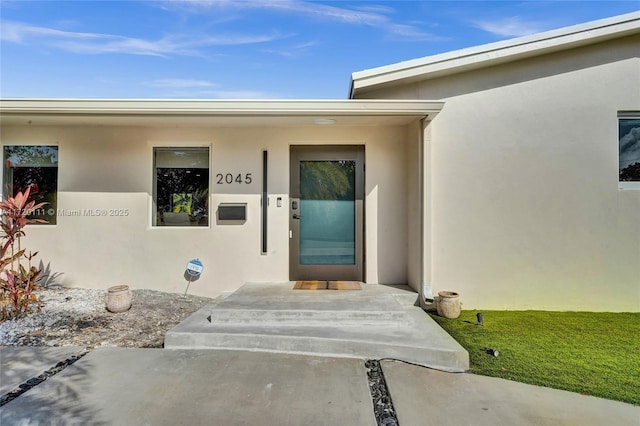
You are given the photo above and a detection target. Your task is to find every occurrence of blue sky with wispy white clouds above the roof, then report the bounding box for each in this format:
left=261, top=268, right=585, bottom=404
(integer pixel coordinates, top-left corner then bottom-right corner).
left=0, top=0, right=640, bottom=99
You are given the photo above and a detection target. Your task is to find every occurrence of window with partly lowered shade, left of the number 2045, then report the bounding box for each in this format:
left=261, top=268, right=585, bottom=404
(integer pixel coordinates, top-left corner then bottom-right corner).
left=153, top=148, right=209, bottom=226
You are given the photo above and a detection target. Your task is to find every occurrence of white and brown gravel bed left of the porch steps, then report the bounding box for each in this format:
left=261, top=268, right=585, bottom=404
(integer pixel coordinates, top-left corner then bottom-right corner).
left=0, top=287, right=213, bottom=349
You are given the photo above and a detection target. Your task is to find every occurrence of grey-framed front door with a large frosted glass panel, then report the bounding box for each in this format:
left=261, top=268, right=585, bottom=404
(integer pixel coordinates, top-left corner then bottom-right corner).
left=289, top=145, right=364, bottom=281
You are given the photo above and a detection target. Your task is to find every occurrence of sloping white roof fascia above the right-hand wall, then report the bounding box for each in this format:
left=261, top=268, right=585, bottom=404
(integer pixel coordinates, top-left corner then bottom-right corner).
left=350, top=12, right=640, bottom=98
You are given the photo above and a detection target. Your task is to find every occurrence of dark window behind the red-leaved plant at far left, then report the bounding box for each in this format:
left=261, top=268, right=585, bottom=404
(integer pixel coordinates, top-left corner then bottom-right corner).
left=3, top=145, right=58, bottom=225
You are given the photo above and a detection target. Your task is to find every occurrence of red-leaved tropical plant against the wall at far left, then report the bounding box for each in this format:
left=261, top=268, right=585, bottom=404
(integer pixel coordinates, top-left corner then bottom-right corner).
left=0, top=188, right=46, bottom=320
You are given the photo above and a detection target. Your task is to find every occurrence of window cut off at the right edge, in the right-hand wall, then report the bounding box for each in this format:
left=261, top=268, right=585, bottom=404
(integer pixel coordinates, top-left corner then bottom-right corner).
left=618, top=114, right=640, bottom=188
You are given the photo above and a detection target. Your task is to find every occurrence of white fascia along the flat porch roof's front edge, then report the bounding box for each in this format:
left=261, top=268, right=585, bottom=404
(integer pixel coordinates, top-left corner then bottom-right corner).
left=0, top=99, right=444, bottom=117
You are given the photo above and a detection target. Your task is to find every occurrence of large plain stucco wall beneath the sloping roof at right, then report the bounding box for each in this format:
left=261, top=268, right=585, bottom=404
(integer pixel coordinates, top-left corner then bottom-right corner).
left=358, top=36, right=640, bottom=311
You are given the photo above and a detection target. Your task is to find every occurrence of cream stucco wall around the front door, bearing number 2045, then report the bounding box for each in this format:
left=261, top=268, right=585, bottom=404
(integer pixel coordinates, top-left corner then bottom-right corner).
left=1, top=126, right=408, bottom=296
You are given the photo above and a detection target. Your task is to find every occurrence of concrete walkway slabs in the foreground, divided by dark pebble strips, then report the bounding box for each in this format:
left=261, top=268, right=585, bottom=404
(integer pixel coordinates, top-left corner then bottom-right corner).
left=0, top=347, right=640, bottom=426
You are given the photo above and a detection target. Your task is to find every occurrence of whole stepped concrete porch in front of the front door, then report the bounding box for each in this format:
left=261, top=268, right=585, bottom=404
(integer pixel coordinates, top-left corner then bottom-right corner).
left=165, top=283, right=469, bottom=372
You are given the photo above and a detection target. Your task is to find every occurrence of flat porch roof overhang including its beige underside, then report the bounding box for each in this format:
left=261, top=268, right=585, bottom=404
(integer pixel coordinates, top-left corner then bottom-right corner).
left=0, top=99, right=444, bottom=127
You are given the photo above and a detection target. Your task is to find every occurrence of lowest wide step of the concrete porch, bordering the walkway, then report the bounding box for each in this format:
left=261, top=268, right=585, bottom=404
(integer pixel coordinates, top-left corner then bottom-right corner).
left=164, top=307, right=469, bottom=372
